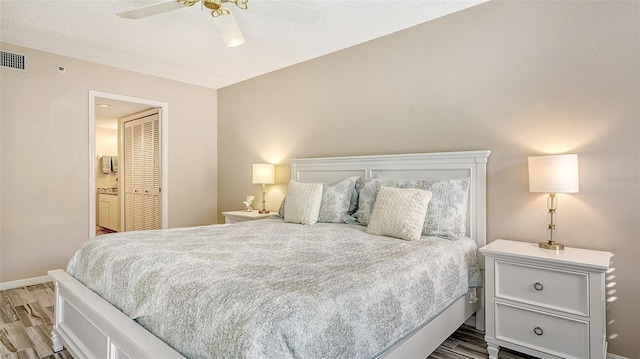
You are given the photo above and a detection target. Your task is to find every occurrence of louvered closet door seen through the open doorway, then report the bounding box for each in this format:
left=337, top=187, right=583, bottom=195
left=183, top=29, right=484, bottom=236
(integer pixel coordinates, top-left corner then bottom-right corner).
left=124, top=113, right=161, bottom=231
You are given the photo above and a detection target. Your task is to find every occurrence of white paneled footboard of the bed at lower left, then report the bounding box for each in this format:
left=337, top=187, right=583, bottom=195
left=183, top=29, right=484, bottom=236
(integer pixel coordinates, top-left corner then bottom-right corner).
left=48, top=269, right=184, bottom=359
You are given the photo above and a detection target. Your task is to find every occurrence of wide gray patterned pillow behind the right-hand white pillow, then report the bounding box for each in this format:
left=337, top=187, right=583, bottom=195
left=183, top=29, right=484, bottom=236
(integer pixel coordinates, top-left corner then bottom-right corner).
left=353, top=177, right=469, bottom=239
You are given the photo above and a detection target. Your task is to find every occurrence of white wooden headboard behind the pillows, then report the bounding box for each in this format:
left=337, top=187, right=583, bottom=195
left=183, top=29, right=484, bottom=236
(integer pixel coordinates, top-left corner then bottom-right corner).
left=289, top=150, right=491, bottom=248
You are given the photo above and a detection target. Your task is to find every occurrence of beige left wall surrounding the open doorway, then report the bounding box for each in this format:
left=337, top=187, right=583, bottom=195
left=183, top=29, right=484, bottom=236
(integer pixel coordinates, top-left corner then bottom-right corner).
left=0, top=43, right=218, bottom=283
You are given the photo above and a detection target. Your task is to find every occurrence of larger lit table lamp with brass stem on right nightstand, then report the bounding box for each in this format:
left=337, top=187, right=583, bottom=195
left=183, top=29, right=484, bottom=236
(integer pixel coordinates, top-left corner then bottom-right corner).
left=529, top=154, right=579, bottom=250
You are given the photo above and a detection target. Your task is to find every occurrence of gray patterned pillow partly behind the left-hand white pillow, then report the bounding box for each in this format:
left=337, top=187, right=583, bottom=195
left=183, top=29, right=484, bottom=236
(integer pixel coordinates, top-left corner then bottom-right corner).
left=318, top=176, right=358, bottom=223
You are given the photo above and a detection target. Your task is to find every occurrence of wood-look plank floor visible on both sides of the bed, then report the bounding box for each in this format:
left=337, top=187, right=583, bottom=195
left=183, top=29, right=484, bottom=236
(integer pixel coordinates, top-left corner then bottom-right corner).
left=0, top=282, right=534, bottom=359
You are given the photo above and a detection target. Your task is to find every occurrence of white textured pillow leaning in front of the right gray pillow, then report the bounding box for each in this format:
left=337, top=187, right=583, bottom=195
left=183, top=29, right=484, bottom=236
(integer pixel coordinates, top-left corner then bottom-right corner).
left=367, top=186, right=432, bottom=240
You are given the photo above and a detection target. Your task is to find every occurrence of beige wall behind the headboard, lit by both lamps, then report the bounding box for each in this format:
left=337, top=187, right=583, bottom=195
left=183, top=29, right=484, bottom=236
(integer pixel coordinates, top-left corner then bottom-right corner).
left=218, top=1, right=640, bottom=358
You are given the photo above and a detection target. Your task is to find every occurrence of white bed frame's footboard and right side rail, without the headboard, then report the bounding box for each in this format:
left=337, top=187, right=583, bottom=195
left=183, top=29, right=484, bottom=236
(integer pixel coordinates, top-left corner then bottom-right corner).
left=48, top=269, right=483, bottom=359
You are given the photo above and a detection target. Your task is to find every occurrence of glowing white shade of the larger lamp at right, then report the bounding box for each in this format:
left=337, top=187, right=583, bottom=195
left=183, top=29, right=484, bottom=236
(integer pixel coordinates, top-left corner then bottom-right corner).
left=529, top=154, right=580, bottom=193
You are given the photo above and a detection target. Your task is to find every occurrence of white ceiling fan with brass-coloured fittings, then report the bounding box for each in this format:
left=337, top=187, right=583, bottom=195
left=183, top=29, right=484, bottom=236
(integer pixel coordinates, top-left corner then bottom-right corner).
left=117, top=0, right=319, bottom=47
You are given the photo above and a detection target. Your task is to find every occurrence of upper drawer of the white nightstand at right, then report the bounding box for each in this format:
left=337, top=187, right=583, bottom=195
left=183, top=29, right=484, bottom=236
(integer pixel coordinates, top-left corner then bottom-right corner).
left=495, top=260, right=589, bottom=317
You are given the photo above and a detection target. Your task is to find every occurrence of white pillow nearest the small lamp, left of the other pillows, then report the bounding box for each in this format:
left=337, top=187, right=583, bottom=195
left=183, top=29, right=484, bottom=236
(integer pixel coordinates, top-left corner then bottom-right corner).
left=284, top=181, right=322, bottom=224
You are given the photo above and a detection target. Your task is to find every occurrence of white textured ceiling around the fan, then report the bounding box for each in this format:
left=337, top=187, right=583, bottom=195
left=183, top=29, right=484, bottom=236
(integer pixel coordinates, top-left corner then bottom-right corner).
left=0, top=0, right=486, bottom=89
